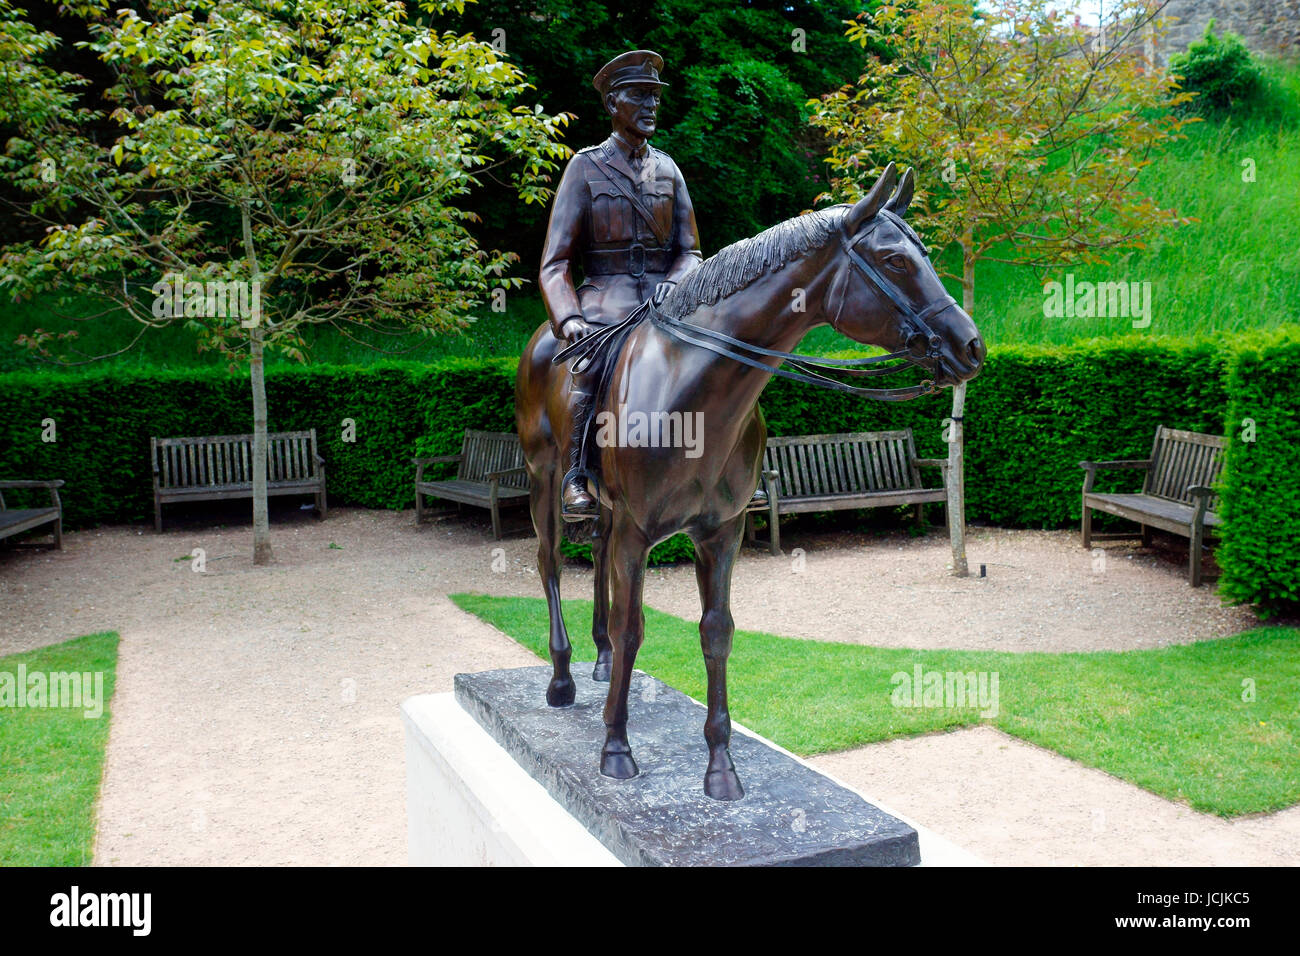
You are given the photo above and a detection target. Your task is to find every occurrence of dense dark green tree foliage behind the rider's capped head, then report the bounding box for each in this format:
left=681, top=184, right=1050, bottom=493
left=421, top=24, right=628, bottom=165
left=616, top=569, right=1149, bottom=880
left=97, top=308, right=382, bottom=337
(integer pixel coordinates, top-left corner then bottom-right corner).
left=428, top=0, right=875, bottom=254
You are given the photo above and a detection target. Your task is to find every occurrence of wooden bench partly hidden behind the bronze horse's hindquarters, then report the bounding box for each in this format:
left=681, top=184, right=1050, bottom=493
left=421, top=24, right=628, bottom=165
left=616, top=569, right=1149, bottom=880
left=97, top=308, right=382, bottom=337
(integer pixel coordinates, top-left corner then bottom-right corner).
left=411, top=429, right=528, bottom=541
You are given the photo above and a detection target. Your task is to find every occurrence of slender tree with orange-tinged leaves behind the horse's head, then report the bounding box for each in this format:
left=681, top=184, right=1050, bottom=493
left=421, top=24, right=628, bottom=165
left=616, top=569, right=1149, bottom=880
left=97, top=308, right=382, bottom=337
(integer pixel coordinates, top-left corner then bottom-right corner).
left=813, top=0, right=1188, bottom=575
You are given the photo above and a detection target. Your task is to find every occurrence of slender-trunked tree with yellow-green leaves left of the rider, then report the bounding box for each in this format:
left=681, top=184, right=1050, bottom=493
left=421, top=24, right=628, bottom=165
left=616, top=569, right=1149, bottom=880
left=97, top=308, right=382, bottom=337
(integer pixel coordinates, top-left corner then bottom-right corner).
left=0, top=0, right=569, bottom=563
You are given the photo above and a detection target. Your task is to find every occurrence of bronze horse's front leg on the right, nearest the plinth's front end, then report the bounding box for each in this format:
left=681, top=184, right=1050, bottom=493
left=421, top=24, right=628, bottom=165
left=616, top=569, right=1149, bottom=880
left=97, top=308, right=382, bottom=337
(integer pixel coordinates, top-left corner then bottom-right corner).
left=696, top=515, right=745, bottom=800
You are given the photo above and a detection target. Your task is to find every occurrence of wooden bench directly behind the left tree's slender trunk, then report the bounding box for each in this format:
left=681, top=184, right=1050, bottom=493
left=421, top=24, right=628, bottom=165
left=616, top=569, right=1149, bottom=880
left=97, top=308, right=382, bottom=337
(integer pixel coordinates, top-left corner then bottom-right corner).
left=150, top=428, right=329, bottom=532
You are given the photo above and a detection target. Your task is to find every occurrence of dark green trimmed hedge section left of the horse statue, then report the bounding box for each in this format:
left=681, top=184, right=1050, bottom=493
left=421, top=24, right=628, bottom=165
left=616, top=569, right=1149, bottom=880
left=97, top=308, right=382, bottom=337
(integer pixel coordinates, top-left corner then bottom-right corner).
left=0, top=359, right=515, bottom=527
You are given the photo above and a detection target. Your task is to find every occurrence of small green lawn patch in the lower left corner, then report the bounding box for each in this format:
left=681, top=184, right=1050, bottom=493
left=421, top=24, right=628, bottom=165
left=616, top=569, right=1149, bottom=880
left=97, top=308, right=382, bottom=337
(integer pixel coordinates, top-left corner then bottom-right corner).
left=0, top=633, right=117, bottom=866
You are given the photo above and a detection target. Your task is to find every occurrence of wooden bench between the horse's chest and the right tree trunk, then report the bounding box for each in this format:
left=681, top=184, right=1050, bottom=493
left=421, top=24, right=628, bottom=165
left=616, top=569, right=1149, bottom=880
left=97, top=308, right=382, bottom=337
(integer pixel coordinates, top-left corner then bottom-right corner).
left=746, top=428, right=948, bottom=554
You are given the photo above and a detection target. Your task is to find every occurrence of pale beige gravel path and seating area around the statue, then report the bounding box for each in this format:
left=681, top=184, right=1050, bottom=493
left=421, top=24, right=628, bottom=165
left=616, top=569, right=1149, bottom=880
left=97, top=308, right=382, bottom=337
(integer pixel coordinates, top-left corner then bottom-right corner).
left=0, top=509, right=1300, bottom=865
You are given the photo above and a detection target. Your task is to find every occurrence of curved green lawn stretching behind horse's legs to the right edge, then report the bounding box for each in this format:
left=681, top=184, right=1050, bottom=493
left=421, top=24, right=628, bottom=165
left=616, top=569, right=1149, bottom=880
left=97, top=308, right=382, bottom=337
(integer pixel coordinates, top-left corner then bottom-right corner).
left=452, top=594, right=1300, bottom=817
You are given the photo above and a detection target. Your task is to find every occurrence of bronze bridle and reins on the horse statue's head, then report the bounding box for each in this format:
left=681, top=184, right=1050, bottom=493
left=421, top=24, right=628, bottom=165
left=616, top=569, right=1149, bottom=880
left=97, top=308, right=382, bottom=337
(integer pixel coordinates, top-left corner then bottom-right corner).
left=647, top=209, right=957, bottom=402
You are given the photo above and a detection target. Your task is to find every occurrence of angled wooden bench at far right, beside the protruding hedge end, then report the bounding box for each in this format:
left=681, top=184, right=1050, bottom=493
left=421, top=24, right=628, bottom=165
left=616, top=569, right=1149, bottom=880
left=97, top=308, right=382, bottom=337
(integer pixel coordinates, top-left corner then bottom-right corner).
left=1079, top=425, right=1227, bottom=588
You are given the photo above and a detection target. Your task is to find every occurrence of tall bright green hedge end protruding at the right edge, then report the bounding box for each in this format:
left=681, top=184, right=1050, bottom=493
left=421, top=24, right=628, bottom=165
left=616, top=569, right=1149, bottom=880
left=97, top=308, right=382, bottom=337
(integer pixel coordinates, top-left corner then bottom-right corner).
left=1216, top=332, right=1300, bottom=614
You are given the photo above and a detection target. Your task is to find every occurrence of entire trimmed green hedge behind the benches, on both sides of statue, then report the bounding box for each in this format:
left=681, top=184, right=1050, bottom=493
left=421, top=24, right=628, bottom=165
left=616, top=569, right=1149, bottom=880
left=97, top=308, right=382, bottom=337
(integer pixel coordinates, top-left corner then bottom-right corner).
left=0, top=334, right=1300, bottom=604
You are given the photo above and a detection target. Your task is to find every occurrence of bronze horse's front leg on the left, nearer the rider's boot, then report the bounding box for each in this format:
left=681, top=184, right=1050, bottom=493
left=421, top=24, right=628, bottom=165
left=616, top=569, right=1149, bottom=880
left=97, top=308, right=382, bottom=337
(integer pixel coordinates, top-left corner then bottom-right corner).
left=601, top=519, right=650, bottom=780
